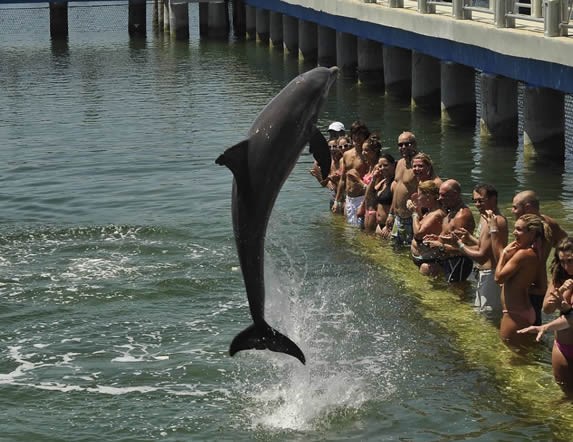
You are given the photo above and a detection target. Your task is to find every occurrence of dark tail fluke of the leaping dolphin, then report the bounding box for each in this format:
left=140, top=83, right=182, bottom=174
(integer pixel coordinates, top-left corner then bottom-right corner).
left=229, top=323, right=306, bottom=364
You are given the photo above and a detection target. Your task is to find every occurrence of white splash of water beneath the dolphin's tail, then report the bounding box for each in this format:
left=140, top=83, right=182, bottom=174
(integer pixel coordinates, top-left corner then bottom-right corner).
left=231, top=247, right=399, bottom=431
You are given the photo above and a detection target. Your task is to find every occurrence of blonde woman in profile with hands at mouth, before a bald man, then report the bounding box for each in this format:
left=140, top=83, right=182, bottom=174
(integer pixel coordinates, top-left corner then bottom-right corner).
left=495, top=214, right=551, bottom=347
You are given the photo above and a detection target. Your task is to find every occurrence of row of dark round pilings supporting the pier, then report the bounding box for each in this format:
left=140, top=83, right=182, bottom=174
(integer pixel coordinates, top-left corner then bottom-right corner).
left=50, top=0, right=565, bottom=162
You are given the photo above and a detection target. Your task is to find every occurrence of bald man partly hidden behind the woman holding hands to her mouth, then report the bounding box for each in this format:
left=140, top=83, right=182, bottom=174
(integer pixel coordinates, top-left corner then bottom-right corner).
left=511, top=190, right=567, bottom=325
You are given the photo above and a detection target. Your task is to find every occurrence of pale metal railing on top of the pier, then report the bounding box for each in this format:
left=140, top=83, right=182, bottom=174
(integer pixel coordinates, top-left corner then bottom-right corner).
left=364, top=0, right=573, bottom=37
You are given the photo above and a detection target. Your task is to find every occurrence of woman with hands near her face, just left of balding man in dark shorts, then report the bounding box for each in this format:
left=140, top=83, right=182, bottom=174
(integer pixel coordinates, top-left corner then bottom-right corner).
left=406, top=180, right=446, bottom=276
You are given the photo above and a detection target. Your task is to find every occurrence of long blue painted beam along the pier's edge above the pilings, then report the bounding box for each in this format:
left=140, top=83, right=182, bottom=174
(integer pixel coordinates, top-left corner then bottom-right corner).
left=245, top=0, right=573, bottom=94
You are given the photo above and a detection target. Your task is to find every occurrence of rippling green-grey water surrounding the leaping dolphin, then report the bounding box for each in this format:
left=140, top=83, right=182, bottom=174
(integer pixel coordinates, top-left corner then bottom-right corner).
left=0, top=1, right=573, bottom=441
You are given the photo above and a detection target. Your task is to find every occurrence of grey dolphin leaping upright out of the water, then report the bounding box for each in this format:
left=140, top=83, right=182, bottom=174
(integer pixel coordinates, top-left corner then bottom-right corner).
left=215, top=67, right=338, bottom=364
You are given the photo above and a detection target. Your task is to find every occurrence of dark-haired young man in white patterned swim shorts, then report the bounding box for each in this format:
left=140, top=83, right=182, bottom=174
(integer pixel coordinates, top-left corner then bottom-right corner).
left=332, top=121, right=370, bottom=225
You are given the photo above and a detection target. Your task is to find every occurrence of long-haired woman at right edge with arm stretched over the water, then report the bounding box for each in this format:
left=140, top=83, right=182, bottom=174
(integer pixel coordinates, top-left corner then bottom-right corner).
left=519, top=238, right=573, bottom=396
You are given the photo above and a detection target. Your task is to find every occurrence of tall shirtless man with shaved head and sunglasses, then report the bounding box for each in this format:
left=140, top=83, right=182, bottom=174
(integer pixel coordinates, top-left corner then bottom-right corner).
left=381, top=132, right=418, bottom=247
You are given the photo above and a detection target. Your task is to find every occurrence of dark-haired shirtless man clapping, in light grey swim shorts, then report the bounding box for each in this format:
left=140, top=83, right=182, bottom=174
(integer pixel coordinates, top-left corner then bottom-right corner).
left=454, top=184, right=508, bottom=319
